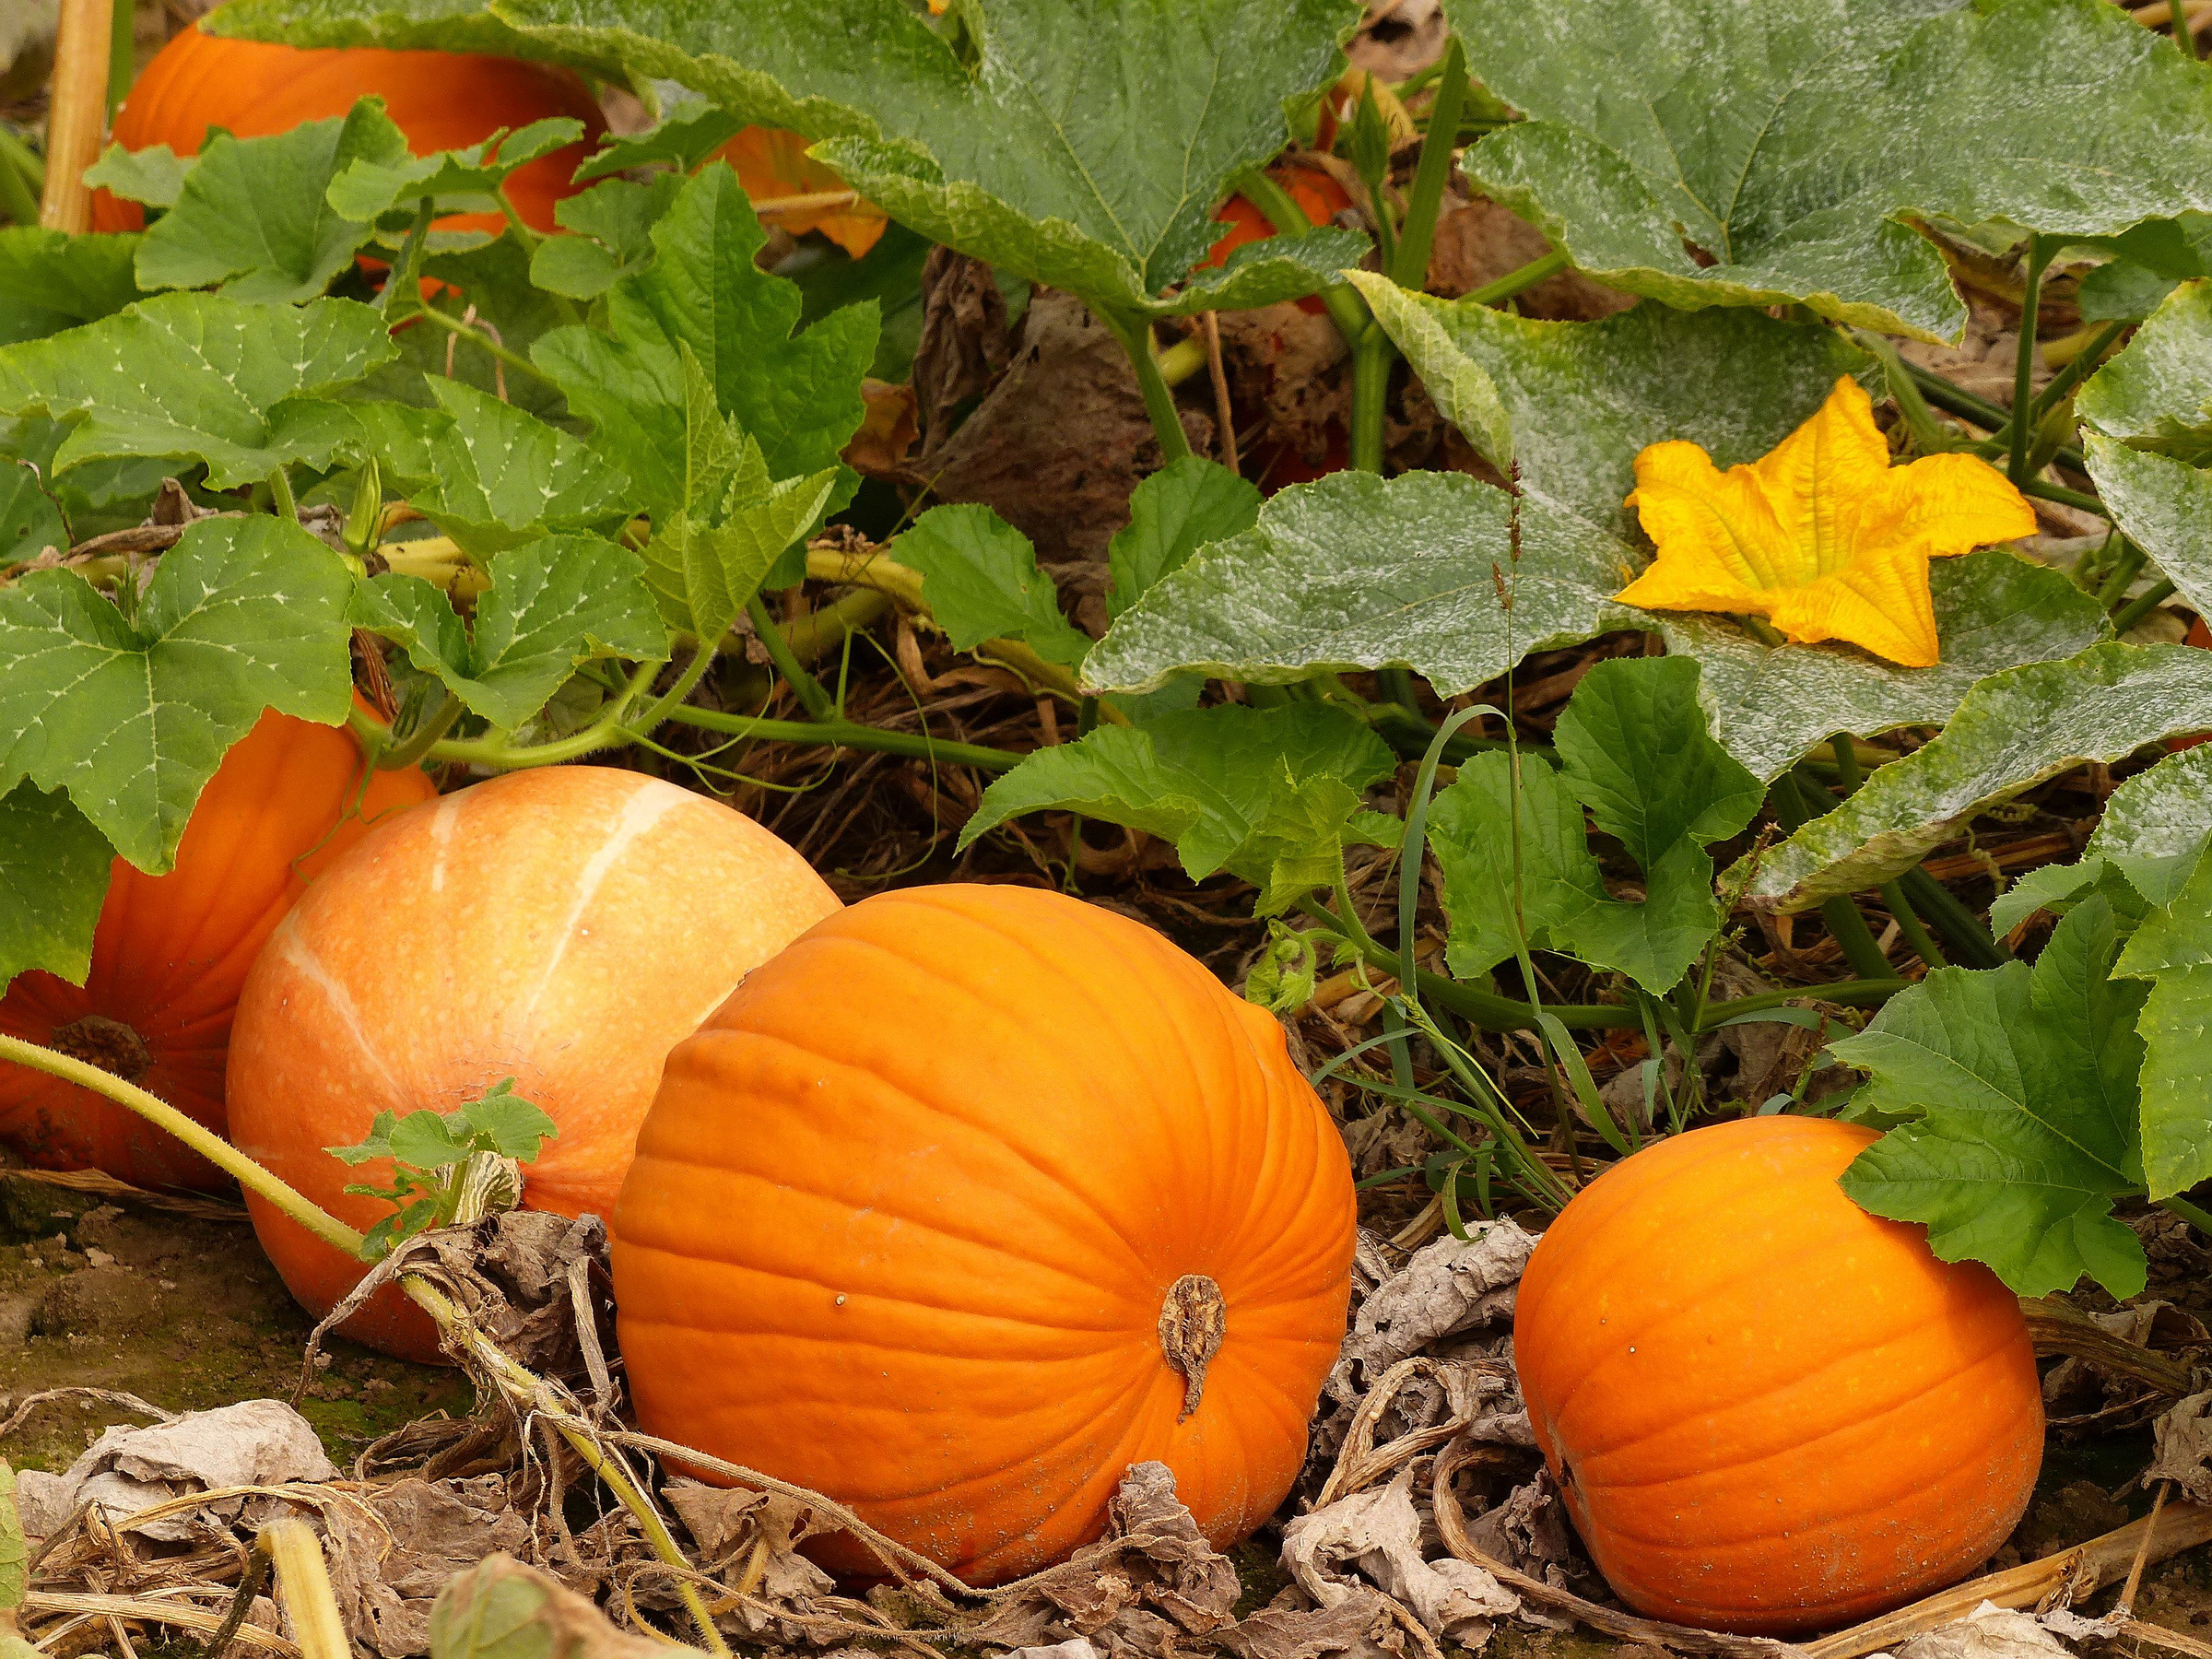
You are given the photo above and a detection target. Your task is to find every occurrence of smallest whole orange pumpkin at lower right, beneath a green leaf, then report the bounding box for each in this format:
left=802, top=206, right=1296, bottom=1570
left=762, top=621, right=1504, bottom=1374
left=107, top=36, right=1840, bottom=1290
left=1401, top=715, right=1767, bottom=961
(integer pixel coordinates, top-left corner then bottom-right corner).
left=1513, top=1117, right=2044, bottom=1635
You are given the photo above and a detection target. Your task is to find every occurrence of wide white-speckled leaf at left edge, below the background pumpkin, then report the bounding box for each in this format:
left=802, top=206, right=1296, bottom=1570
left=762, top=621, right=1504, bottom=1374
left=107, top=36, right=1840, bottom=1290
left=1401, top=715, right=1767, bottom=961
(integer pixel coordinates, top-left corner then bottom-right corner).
left=0, top=294, right=394, bottom=488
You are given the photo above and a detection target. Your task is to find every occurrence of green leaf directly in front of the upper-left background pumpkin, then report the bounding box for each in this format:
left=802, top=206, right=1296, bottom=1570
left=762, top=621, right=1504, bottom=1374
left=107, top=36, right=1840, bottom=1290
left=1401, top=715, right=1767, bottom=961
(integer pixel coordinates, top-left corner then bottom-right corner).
left=137, top=98, right=407, bottom=303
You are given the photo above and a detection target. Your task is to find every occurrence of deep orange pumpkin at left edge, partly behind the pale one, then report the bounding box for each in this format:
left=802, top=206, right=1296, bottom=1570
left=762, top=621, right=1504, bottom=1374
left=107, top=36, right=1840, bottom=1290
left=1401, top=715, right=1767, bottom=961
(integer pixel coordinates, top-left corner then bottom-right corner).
left=0, top=710, right=436, bottom=1193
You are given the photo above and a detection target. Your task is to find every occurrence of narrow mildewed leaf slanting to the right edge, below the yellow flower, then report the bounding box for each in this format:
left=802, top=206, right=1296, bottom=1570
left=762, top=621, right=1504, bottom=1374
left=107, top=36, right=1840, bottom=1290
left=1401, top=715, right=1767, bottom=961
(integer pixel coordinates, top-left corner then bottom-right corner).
left=1746, top=643, right=2212, bottom=912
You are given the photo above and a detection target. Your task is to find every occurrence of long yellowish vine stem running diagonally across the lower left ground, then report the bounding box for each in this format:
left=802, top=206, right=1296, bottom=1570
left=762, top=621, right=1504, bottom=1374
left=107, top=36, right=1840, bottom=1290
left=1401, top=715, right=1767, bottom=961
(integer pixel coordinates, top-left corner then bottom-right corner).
left=0, top=1033, right=730, bottom=1659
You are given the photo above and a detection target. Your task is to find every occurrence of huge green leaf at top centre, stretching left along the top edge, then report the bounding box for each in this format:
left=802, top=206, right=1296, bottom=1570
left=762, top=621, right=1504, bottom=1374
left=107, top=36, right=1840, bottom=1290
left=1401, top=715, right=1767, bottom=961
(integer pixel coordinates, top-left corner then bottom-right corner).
left=221, top=0, right=1362, bottom=312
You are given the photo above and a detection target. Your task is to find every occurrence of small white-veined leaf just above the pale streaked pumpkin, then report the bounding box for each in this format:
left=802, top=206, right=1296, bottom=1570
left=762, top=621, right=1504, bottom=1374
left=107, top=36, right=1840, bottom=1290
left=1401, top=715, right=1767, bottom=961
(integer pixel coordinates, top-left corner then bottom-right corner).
left=352, top=535, right=668, bottom=730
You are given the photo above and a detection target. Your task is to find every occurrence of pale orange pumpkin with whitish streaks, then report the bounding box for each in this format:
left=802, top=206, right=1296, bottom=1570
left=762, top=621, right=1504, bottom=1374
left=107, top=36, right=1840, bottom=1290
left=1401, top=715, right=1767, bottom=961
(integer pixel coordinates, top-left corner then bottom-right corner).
left=230, top=765, right=839, bottom=1360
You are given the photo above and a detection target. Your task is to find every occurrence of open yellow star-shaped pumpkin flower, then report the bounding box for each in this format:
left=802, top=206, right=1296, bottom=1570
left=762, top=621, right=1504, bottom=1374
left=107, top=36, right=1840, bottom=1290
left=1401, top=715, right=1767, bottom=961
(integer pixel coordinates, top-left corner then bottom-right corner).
left=1619, top=376, right=2035, bottom=668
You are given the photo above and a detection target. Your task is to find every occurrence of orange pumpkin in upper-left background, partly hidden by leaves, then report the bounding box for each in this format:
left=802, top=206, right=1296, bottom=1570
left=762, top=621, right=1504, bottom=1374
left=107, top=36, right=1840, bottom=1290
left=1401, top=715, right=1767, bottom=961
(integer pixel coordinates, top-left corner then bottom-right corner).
left=93, top=22, right=606, bottom=234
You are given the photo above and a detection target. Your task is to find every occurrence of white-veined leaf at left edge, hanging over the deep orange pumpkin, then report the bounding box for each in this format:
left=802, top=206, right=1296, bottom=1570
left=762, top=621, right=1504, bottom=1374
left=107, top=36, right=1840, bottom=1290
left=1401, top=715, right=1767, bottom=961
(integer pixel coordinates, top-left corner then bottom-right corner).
left=0, top=520, right=354, bottom=874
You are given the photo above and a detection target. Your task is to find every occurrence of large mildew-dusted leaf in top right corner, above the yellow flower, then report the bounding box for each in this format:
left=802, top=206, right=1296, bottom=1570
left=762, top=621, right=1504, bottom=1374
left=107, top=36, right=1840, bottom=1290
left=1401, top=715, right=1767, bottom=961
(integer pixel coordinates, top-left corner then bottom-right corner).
left=1444, top=0, right=2212, bottom=338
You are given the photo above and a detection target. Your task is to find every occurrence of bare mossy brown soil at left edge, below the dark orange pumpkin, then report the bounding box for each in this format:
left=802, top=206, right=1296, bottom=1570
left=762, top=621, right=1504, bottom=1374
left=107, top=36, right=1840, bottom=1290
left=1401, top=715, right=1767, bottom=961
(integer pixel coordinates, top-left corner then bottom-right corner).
left=0, top=1174, right=474, bottom=1471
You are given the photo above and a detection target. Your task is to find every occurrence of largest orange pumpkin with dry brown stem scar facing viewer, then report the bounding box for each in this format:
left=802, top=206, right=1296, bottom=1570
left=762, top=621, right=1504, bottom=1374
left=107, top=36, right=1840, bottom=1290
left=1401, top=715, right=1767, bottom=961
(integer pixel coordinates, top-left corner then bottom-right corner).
left=615, top=885, right=1354, bottom=1583
